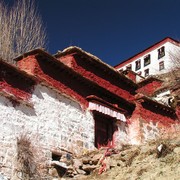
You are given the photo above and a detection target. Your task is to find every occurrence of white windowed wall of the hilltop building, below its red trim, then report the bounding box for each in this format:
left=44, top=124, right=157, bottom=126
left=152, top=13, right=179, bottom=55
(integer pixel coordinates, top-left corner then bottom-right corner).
left=118, top=42, right=180, bottom=76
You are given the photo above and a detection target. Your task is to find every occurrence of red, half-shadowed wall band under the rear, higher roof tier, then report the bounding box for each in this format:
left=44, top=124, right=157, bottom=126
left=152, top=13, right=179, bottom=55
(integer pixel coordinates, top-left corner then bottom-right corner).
left=60, top=55, right=134, bottom=100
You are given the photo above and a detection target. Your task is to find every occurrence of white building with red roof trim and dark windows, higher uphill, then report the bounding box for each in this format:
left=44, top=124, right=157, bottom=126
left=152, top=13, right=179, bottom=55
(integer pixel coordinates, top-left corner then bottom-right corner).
left=115, top=37, right=180, bottom=77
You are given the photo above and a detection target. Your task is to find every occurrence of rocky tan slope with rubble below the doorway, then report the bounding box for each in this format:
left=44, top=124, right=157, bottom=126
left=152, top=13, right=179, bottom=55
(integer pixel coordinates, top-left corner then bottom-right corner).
left=50, top=137, right=180, bottom=180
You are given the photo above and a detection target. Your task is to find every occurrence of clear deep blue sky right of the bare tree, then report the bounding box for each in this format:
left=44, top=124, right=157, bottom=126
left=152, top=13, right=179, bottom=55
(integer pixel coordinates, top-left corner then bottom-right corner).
left=5, top=0, right=180, bottom=65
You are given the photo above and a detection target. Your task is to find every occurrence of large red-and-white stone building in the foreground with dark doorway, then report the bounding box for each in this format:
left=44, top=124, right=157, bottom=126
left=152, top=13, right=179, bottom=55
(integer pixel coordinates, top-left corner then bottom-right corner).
left=0, top=47, right=179, bottom=179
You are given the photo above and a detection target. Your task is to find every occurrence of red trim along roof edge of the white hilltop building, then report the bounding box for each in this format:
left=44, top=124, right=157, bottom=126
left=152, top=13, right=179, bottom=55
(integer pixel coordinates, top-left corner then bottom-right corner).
left=114, top=37, right=180, bottom=69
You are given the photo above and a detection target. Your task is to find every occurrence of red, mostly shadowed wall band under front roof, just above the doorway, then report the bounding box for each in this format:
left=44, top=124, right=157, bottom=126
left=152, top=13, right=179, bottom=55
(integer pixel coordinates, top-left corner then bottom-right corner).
left=17, top=54, right=134, bottom=110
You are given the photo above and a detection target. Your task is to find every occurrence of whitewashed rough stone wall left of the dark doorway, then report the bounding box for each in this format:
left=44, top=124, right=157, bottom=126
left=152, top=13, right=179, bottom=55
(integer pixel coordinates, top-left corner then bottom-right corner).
left=0, top=85, right=94, bottom=179
